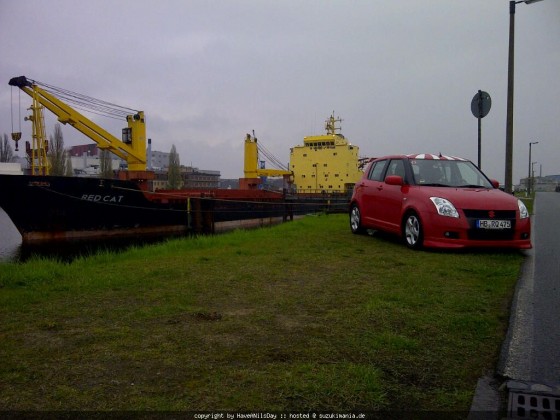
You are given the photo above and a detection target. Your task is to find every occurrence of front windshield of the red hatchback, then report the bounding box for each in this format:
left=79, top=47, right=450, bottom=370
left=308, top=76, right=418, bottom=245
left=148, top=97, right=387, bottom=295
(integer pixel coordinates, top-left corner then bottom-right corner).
left=410, top=159, right=493, bottom=188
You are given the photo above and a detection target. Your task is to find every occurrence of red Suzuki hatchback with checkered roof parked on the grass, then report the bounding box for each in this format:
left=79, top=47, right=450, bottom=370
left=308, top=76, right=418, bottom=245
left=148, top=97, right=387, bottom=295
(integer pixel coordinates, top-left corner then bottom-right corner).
left=350, top=154, right=532, bottom=249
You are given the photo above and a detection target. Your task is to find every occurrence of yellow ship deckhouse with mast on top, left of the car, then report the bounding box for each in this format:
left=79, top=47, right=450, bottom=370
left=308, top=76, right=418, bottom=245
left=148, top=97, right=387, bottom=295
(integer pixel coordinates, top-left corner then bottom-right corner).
left=290, top=113, right=362, bottom=193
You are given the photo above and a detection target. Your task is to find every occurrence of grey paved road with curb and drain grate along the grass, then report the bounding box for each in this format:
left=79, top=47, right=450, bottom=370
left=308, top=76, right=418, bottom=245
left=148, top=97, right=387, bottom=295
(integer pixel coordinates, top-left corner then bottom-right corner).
left=470, top=193, right=560, bottom=419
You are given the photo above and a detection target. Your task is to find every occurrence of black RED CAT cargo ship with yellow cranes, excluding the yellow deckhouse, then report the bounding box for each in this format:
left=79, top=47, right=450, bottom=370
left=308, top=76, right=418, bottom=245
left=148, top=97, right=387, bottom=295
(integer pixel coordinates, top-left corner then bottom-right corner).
left=0, top=76, right=349, bottom=244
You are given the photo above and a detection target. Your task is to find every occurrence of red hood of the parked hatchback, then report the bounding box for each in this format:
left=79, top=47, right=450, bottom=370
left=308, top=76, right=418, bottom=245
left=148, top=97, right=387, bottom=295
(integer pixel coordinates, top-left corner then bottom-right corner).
left=419, top=187, right=519, bottom=210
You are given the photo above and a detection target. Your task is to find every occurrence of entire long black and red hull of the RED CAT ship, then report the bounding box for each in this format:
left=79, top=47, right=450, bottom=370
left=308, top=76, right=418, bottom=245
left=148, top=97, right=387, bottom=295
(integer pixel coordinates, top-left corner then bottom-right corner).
left=0, top=175, right=347, bottom=243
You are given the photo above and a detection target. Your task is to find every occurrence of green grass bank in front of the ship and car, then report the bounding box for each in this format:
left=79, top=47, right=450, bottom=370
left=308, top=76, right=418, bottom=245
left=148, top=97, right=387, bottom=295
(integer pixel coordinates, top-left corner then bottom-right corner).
left=0, top=215, right=523, bottom=412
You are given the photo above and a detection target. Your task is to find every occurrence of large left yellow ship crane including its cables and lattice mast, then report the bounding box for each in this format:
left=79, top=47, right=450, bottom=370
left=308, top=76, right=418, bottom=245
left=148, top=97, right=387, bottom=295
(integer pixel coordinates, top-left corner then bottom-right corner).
left=9, top=76, right=152, bottom=179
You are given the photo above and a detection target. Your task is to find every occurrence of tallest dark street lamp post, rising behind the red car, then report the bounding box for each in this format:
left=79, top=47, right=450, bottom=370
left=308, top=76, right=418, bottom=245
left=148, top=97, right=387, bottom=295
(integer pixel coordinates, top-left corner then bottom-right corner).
left=504, top=0, right=542, bottom=193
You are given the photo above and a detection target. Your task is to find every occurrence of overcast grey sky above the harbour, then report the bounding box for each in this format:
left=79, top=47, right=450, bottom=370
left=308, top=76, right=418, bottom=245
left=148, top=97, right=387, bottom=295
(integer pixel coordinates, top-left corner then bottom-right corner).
left=0, top=0, right=560, bottom=183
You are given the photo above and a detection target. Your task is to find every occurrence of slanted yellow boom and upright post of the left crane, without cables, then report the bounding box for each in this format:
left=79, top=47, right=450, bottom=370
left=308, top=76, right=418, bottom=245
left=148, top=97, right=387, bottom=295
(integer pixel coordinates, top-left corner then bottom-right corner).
left=9, top=76, right=146, bottom=171
